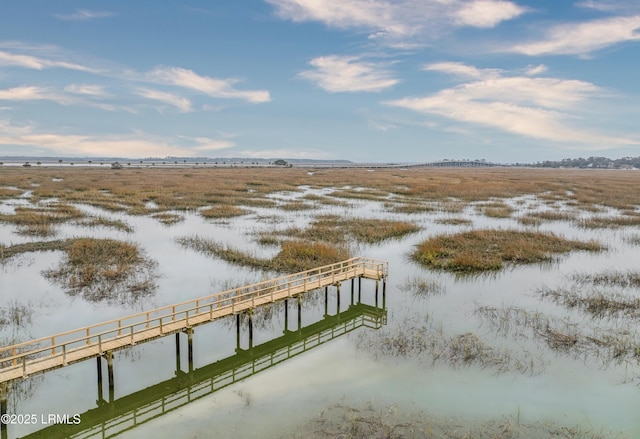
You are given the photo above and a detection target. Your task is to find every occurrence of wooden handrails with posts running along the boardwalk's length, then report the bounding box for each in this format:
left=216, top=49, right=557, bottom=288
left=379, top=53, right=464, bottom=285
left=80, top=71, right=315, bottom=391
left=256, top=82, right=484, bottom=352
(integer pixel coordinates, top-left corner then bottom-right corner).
left=0, top=257, right=388, bottom=384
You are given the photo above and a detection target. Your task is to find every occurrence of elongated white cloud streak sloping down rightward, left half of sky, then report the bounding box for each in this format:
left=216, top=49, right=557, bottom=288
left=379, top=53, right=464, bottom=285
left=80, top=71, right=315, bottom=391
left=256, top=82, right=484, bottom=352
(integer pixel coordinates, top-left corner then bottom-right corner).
left=145, top=67, right=271, bottom=103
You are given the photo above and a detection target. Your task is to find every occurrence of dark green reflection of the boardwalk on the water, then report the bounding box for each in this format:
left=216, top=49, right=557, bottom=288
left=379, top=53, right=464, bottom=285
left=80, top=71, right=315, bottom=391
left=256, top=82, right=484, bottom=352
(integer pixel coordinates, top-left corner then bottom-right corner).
left=24, top=302, right=387, bottom=438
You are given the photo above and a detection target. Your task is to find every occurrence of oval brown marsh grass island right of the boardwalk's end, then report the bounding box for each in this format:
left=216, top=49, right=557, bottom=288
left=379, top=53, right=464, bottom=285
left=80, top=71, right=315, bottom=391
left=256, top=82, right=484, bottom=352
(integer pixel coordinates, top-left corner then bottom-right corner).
left=412, top=230, right=602, bottom=273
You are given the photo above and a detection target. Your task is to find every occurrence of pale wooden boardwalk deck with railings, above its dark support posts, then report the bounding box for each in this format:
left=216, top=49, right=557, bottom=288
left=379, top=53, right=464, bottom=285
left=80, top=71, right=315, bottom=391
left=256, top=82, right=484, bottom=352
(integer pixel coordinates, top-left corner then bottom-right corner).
left=0, top=257, right=388, bottom=384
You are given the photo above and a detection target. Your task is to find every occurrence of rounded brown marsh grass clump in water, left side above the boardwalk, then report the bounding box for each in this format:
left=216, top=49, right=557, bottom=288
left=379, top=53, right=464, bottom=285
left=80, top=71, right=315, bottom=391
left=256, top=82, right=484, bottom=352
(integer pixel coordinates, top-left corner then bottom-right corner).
left=43, top=238, right=157, bottom=304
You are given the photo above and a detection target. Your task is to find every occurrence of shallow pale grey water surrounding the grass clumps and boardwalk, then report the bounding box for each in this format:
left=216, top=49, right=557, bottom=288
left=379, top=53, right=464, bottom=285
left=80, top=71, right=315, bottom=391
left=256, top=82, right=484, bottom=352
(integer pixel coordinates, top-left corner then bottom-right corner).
left=0, top=193, right=640, bottom=438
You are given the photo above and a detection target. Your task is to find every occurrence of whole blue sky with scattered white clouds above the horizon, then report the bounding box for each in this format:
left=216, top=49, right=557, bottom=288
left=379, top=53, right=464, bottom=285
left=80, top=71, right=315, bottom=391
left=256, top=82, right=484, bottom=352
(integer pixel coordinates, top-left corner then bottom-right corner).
left=0, top=0, right=640, bottom=163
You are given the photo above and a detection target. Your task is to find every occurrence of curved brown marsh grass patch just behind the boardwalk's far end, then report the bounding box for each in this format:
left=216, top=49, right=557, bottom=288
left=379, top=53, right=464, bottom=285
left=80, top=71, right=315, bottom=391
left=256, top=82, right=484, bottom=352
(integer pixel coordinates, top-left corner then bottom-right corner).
left=176, top=236, right=350, bottom=273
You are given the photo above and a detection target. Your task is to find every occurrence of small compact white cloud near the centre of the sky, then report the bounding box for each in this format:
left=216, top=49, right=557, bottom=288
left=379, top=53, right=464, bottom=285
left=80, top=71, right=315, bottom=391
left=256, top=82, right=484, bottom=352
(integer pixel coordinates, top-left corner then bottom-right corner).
left=300, top=55, right=398, bottom=93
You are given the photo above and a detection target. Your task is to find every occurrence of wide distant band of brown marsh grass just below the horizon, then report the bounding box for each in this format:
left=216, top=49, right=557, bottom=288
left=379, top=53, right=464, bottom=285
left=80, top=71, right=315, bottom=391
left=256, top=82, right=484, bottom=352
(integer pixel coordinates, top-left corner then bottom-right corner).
left=0, top=167, right=640, bottom=227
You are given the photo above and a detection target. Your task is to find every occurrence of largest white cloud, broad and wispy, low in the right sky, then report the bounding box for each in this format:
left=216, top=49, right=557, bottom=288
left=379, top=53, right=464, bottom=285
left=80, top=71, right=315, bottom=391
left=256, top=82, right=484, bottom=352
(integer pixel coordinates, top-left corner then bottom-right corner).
left=386, top=64, right=638, bottom=149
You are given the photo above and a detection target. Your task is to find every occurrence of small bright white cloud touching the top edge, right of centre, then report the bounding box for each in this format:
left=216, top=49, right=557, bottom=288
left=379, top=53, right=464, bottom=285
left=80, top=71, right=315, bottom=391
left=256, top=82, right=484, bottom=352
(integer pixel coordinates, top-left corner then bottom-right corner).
left=455, top=0, right=526, bottom=28
